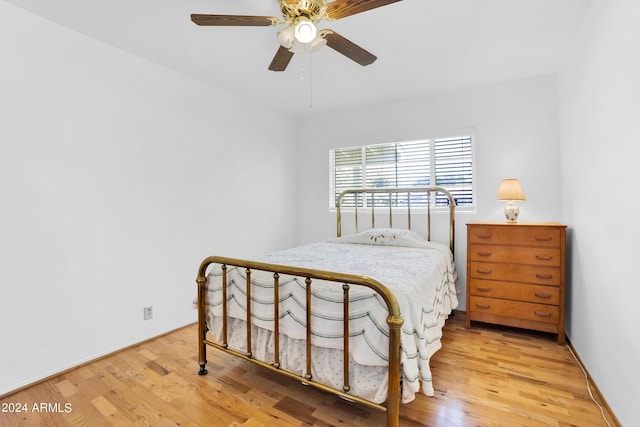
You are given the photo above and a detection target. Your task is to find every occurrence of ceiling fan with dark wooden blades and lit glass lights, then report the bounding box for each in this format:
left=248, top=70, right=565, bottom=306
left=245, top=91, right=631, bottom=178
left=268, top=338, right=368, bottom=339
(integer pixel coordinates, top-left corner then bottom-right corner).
left=191, top=0, right=401, bottom=71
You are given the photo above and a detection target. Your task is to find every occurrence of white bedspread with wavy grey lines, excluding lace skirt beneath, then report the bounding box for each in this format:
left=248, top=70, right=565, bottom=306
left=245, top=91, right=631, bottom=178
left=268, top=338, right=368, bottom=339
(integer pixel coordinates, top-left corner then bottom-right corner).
left=202, top=232, right=458, bottom=402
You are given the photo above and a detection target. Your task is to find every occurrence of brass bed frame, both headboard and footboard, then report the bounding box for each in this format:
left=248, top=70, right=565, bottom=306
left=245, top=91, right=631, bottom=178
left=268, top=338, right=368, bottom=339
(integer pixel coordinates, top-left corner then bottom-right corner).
left=196, top=187, right=456, bottom=427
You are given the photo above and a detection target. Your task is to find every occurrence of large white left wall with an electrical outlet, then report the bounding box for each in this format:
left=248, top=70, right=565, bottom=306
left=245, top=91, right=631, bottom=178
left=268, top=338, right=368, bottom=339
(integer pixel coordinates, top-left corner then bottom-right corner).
left=0, top=1, right=295, bottom=395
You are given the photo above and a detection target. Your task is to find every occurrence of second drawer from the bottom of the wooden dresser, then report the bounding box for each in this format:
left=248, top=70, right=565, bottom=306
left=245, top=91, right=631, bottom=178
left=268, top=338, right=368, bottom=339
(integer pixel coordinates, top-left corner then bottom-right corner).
left=469, top=279, right=560, bottom=305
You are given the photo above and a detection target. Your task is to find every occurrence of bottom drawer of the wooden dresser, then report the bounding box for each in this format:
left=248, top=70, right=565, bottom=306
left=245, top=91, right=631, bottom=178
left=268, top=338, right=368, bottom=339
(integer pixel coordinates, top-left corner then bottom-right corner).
left=469, top=295, right=560, bottom=323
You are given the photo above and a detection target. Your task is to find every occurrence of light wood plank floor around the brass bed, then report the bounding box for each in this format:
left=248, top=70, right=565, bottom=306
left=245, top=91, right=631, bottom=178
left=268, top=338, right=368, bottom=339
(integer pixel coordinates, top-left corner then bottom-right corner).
left=0, top=313, right=616, bottom=427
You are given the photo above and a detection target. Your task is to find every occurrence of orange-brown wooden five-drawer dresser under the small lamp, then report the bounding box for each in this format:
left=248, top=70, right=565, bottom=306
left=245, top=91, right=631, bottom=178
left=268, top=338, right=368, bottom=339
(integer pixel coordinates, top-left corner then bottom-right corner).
left=466, top=222, right=567, bottom=344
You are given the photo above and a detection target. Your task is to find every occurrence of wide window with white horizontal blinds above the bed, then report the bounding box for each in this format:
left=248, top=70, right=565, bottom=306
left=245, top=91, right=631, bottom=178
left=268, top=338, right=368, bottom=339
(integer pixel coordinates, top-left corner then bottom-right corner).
left=329, top=135, right=474, bottom=209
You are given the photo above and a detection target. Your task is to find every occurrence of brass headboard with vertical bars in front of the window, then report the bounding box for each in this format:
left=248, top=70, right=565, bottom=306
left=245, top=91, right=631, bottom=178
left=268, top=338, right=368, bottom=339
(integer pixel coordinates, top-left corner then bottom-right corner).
left=336, top=187, right=456, bottom=254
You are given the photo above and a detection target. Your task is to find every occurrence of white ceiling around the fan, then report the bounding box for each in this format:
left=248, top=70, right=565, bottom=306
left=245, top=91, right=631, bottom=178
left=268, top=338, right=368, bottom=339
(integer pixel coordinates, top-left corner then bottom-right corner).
left=5, top=0, right=592, bottom=116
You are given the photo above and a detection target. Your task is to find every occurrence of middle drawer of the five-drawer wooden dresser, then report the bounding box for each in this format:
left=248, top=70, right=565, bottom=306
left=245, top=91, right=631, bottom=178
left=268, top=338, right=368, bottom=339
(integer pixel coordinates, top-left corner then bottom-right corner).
left=468, top=261, right=562, bottom=286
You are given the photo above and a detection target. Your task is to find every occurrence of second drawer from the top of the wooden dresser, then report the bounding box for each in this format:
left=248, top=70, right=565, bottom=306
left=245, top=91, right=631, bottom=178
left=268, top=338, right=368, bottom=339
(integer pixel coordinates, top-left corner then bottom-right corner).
left=469, top=244, right=561, bottom=267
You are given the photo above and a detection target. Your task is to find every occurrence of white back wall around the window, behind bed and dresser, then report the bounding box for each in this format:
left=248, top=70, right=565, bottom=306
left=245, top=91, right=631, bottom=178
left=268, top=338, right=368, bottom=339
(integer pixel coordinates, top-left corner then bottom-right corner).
left=297, top=75, right=561, bottom=300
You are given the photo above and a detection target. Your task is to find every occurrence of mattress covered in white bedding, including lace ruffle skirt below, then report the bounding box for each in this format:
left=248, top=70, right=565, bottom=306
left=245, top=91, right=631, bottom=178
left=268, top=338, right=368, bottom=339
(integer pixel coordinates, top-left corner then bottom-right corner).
left=206, top=229, right=458, bottom=403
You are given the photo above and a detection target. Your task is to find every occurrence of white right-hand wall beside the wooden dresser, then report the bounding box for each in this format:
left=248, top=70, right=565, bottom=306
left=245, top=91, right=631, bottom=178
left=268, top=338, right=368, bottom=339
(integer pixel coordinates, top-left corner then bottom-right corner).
left=559, top=0, right=640, bottom=426
